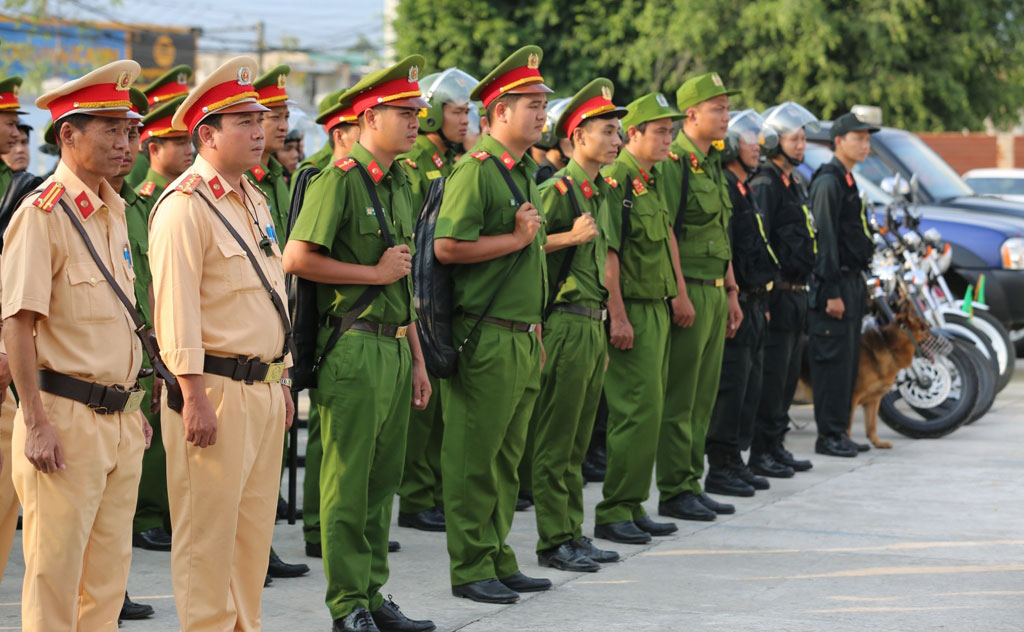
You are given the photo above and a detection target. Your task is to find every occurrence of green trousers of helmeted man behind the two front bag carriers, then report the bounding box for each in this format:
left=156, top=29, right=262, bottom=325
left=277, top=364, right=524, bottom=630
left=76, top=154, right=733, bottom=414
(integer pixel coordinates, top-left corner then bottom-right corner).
left=398, top=377, right=444, bottom=513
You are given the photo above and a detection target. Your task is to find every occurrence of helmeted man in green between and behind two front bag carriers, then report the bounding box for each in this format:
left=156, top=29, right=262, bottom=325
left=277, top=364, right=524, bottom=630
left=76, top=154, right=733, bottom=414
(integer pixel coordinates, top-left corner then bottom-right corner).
left=398, top=68, right=478, bottom=532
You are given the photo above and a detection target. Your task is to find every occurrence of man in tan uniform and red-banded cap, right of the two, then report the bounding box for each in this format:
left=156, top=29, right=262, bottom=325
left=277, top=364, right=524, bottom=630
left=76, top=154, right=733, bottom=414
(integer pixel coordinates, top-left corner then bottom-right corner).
left=150, top=57, right=293, bottom=632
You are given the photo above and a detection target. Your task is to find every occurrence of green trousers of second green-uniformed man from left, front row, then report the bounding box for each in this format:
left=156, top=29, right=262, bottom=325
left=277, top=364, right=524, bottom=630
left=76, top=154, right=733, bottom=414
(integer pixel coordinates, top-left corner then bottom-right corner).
left=441, top=318, right=541, bottom=586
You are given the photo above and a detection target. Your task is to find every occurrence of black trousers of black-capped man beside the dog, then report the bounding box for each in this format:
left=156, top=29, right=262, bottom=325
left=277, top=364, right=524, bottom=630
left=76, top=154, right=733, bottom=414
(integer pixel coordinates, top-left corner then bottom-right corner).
left=807, top=271, right=867, bottom=435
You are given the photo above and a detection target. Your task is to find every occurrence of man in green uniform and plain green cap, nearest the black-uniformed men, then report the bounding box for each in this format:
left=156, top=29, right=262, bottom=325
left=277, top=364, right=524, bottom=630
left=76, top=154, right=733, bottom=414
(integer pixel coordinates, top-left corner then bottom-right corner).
left=657, top=73, right=742, bottom=520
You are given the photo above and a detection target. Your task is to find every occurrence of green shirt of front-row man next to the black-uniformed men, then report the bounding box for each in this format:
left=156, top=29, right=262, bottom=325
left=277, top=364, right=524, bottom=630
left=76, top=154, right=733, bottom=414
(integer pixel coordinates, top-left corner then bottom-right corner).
left=657, top=132, right=732, bottom=279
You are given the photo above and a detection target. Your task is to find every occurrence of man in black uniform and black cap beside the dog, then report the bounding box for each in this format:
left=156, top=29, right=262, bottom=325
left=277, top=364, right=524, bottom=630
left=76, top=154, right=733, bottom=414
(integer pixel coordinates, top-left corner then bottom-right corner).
left=807, top=113, right=879, bottom=457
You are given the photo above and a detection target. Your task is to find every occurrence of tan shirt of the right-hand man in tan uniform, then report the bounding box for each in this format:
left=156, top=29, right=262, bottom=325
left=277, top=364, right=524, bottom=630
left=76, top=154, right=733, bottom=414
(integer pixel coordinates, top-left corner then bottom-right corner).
left=150, top=156, right=291, bottom=375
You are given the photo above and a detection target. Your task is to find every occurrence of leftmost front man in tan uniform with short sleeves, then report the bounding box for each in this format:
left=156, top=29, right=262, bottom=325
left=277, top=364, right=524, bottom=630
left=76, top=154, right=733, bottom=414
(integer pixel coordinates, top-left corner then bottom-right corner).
left=2, top=60, right=152, bottom=631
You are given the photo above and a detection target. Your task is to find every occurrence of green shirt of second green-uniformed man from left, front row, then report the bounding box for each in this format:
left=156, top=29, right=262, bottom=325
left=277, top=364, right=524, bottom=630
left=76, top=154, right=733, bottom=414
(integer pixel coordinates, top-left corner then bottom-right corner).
left=434, top=135, right=548, bottom=323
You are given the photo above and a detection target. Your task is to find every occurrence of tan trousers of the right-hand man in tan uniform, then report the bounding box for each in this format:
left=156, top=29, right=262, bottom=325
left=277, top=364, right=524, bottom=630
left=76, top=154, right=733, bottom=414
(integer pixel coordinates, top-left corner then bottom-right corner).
left=161, top=374, right=285, bottom=632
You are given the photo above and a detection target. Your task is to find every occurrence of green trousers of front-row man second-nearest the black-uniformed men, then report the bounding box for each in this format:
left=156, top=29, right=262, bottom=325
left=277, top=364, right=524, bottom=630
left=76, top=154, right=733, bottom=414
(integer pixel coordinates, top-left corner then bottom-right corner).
left=596, top=298, right=671, bottom=524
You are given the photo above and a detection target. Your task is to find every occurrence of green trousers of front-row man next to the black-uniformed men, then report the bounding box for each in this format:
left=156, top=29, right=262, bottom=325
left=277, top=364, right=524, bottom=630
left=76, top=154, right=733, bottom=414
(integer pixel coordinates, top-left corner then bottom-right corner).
left=657, top=283, right=728, bottom=502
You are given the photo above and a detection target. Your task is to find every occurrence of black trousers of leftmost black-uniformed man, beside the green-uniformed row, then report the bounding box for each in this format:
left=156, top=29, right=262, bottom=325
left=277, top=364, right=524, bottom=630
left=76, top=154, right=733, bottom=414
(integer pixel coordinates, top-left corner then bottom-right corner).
left=705, top=297, right=767, bottom=467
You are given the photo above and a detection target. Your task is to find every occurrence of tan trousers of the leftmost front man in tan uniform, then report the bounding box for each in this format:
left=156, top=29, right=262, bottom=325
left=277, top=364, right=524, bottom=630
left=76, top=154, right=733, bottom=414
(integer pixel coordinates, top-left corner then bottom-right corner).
left=11, top=392, right=145, bottom=632
